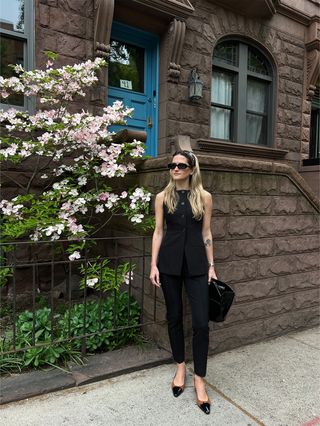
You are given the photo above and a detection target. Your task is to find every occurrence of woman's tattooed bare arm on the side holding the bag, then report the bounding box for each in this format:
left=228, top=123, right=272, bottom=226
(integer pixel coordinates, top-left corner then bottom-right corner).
left=202, top=191, right=217, bottom=282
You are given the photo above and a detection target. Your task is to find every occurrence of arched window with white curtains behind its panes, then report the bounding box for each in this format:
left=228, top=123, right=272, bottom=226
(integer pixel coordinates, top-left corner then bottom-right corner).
left=210, top=40, right=273, bottom=146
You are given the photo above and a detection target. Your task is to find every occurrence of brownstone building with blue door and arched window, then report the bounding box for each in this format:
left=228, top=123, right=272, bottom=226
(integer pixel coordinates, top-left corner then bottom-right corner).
left=0, top=0, right=320, bottom=351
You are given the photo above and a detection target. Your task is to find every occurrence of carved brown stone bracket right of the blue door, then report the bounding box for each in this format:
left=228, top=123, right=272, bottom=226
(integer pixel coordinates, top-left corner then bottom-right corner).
left=168, top=18, right=186, bottom=83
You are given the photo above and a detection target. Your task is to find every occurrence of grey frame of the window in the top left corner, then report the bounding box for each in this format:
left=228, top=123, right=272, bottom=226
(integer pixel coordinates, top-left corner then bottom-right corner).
left=0, top=0, right=35, bottom=111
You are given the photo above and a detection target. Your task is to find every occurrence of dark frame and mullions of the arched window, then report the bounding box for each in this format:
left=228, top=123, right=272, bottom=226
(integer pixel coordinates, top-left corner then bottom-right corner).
left=210, top=37, right=275, bottom=147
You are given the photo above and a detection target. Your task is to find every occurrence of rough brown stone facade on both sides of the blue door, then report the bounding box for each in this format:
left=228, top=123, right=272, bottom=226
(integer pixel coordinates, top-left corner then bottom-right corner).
left=35, top=0, right=316, bottom=169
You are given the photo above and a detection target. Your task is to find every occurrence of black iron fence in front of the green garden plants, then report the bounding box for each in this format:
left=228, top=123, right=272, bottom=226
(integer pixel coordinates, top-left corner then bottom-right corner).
left=0, top=236, right=163, bottom=355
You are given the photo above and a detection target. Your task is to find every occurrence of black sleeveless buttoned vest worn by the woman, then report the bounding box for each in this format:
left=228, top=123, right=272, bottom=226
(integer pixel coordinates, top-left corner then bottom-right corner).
left=158, top=190, right=208, bottom=276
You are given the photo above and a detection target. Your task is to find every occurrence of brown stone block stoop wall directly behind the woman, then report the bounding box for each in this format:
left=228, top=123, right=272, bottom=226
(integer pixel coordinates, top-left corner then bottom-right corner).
left=115, top=157, right=320, bottom=356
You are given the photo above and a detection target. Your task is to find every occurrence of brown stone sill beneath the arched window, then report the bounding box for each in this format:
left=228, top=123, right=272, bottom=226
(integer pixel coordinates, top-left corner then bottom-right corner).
left=198, top=139, right=288, bottom=160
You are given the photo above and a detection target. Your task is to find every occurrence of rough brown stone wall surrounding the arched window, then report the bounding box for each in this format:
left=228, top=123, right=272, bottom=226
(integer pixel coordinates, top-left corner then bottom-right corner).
left=167, top=1, right=310, bottom=168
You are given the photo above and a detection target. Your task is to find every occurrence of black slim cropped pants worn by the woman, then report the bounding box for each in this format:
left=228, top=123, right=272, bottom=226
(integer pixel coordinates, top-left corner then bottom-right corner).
left=160, top=273, right=209, bottom=377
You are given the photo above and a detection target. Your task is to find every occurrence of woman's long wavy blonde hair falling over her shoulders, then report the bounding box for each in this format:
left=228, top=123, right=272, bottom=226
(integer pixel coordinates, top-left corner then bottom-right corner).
left=164, top=151, right=204, bottom=220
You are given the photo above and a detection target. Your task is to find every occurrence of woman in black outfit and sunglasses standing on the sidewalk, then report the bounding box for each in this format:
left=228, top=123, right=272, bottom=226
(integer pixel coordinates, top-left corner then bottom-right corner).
left=150, top=151, right=217, bottom=414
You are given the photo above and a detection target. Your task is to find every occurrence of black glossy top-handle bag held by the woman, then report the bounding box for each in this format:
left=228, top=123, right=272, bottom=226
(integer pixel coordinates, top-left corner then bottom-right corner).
left=209, top=279, right=234, bottom=322
